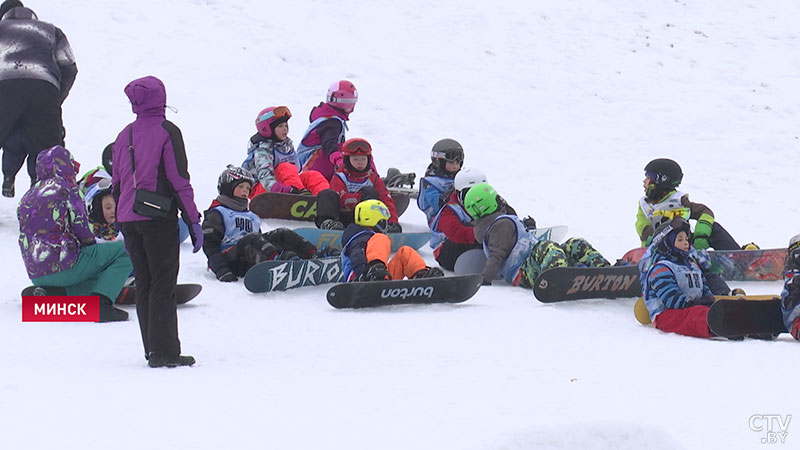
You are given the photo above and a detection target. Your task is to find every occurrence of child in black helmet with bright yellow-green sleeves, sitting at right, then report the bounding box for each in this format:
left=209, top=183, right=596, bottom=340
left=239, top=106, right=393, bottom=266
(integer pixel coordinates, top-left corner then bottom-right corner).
left=636, top=158, right=744, bottom=250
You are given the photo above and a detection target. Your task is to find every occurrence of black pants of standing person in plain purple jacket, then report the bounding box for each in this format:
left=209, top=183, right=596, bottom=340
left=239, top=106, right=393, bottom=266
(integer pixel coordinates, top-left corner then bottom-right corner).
left=120, top=217, right=181, bottom=357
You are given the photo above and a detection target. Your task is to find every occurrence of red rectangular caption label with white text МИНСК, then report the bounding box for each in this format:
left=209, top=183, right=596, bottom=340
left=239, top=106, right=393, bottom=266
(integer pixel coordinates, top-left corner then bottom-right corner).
left=22, top=295, right=100, bottom=322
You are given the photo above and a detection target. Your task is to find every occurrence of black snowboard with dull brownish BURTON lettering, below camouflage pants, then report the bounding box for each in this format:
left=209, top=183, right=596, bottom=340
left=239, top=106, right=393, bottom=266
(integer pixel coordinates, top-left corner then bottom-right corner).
left=533, top=266, right=642, bottom=303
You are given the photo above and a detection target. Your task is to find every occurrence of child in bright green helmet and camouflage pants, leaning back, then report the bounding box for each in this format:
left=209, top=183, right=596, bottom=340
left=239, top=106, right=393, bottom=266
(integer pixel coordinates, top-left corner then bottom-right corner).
left=464, top=183, right=610, bottom=288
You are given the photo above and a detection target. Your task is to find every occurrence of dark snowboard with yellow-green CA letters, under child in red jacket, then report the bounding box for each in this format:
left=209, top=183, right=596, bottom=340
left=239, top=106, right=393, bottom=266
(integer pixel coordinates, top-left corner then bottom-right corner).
left=250, top=191, right=409, bottom=222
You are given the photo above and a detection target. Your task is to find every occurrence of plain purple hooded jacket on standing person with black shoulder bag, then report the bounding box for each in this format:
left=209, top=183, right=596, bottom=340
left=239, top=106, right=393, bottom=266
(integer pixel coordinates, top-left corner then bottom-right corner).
left=111, top=76, right=200, bottom=229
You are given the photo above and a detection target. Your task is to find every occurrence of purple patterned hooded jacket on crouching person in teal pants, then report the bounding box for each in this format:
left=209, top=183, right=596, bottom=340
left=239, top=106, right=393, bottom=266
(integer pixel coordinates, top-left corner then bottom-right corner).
left=17, top=145, right=94, bottom=279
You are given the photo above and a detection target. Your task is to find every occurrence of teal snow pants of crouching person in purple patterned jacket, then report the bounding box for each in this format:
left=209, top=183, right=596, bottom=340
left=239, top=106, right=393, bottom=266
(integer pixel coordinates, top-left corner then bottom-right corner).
left=31, top=241, right=133, bottom=302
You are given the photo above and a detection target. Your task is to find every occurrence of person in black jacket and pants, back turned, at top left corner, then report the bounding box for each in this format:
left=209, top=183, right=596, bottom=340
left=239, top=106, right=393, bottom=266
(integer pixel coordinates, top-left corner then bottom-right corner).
left=0, top=0, right=78, bottom=197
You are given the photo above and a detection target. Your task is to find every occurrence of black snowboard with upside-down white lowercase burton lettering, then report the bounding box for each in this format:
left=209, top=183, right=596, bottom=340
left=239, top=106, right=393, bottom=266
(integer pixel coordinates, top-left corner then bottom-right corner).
left=327, top=275, right=481, bottom=309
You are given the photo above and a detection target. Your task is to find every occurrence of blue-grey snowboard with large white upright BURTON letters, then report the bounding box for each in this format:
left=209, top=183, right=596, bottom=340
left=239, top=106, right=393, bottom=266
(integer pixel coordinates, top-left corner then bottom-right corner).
left=244, top=257, right=342, bottom=293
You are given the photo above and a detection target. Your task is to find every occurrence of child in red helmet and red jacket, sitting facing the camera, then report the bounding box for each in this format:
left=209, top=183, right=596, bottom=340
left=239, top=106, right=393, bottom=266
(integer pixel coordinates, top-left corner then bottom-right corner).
left=314, top=138, right=403, bottom=233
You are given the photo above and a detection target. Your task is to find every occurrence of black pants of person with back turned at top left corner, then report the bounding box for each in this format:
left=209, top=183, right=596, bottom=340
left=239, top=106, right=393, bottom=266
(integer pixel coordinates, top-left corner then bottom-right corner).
left=0, top=78, right=64, bottom=179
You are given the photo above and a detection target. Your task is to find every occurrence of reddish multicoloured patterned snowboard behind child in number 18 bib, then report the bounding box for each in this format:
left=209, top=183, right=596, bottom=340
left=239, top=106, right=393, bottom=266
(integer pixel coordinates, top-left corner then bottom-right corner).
left=621, top=247, right=786, bottom=281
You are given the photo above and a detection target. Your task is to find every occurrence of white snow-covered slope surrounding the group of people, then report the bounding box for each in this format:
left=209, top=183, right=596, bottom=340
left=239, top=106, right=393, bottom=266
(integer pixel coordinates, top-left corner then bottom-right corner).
left=0, top=0, right=800, bottom=450
